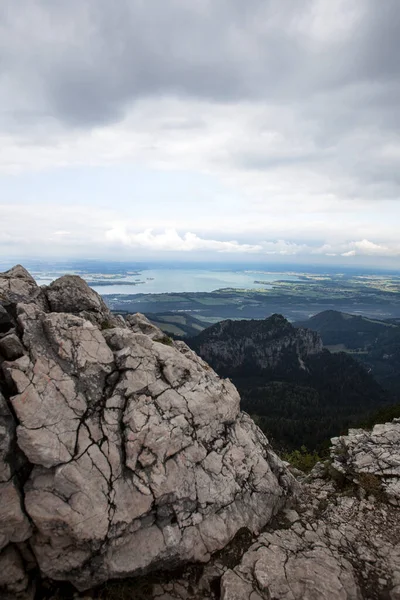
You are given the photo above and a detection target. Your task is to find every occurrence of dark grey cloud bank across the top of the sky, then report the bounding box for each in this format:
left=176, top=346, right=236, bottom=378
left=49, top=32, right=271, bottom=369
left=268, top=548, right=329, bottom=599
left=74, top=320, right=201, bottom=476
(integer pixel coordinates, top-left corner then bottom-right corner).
left=0, top=0, right=400, bottom=127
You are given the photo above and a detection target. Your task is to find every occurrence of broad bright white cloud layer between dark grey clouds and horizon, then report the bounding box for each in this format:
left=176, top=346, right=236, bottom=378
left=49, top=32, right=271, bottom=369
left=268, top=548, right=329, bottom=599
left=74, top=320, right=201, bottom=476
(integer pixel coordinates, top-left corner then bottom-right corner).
left=0, top=97, right=400, bottom=268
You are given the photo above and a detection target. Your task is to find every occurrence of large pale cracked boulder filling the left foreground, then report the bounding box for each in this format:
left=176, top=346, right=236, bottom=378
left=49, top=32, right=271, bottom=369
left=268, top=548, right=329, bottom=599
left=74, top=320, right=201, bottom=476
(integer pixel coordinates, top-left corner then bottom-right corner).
left=0, top=266, right=296, bottom=600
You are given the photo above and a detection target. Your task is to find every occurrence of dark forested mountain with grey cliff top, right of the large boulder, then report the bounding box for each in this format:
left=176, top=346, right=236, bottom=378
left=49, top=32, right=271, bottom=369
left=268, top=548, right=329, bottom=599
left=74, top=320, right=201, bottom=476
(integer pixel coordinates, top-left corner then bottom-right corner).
left=189, top=315, right=391, bottom=449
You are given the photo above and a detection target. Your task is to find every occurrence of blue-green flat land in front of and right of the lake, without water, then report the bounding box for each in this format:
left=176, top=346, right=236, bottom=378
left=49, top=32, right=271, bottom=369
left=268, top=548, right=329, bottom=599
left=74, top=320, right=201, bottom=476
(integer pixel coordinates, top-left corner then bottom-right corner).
left=104, top=272, right=400, bottom=336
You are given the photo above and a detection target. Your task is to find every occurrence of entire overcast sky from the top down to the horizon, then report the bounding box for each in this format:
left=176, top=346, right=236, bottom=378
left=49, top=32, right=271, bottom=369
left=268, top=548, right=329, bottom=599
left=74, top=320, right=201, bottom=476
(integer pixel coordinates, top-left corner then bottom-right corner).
left=0, top=0, right=400, bottom=267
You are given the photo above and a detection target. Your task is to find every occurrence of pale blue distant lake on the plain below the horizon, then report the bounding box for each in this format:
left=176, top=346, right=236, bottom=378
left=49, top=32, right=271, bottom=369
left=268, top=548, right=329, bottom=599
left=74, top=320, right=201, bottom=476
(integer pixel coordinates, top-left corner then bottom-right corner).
left=35, top=269, right=298, bottom=296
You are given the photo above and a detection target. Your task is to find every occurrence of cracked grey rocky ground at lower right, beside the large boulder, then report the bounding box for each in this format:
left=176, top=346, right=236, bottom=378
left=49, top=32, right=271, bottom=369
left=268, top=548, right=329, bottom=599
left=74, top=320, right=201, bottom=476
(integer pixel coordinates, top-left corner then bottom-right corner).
left=221, top=420, right=400, bottom=600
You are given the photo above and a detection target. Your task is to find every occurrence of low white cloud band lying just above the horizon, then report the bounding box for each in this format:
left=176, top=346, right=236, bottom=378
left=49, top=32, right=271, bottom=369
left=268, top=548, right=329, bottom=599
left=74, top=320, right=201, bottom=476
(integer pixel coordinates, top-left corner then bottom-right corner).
left=0, top=203, right=400, bottom=261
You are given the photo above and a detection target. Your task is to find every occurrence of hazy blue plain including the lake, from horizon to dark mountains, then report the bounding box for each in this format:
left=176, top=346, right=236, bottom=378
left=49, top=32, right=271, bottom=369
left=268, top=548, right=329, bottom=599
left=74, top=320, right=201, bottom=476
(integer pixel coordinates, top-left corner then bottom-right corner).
left=0, top=260, right=400, bottom=336
